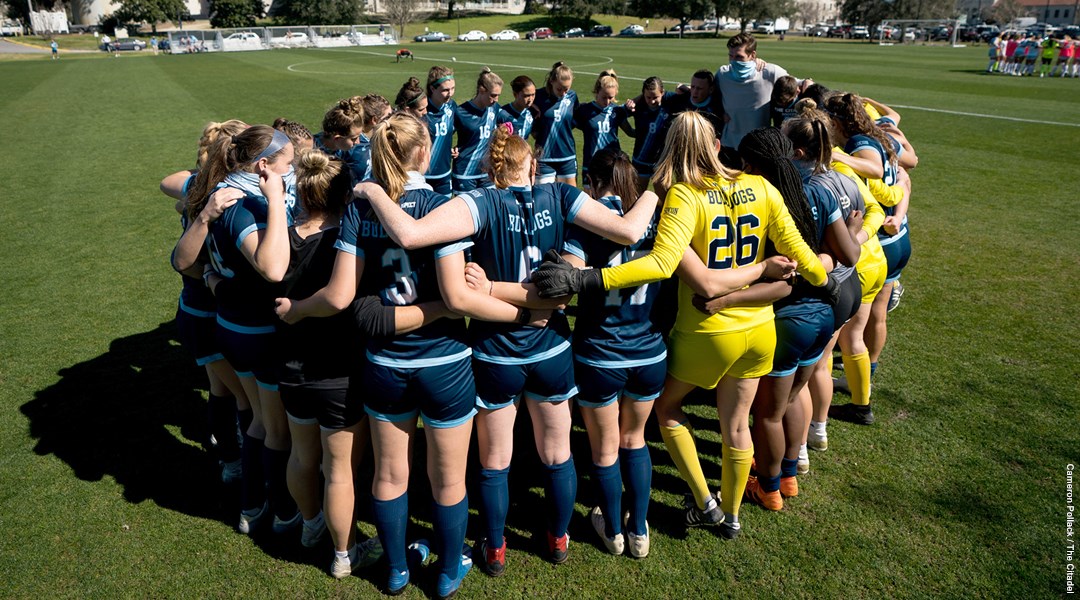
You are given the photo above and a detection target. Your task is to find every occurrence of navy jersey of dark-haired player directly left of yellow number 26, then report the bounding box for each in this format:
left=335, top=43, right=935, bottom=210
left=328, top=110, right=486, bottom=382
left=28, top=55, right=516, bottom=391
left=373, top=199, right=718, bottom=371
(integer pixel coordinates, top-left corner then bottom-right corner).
left=563, top=196, right=667, bottom=369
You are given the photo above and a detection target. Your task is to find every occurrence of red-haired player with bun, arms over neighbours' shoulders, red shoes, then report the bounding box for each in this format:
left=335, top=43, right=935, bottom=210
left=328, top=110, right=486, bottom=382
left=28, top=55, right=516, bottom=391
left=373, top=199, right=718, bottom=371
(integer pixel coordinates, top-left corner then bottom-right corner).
left=356, top=127, right=658, bottom=576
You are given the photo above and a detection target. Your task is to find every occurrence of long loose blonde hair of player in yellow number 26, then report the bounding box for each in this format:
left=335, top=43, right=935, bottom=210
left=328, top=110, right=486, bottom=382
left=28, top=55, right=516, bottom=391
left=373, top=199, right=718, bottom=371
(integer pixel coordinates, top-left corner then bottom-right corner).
left=652, top=111, right=740, bottom=189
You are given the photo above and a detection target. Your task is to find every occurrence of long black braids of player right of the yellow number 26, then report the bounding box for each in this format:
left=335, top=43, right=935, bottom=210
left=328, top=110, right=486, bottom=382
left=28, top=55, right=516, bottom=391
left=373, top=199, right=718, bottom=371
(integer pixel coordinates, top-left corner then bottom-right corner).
left=739, top=127, right=821, bottom=254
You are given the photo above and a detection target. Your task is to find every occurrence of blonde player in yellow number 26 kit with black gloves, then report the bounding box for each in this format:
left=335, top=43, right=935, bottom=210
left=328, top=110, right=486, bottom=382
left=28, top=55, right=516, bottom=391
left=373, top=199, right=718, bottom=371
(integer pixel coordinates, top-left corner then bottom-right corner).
left=534, top=112, right=827, bottom=538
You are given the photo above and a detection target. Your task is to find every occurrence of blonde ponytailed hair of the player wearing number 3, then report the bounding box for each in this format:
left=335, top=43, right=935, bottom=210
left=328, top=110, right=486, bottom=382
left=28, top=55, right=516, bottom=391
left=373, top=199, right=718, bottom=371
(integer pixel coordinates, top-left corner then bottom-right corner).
left=372, top=112, right=431, bottom=200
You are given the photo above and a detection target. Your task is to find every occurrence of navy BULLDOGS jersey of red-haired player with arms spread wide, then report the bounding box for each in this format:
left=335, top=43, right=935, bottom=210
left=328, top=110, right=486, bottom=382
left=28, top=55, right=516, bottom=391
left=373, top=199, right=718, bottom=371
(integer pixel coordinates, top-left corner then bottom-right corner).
left=461, top=183, right=589, bottom=365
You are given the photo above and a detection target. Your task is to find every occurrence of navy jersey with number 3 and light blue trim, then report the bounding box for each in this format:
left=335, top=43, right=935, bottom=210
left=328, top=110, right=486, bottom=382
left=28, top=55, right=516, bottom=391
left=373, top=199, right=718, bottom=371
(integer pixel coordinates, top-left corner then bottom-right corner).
left=337, top=174, right=470, bottom=368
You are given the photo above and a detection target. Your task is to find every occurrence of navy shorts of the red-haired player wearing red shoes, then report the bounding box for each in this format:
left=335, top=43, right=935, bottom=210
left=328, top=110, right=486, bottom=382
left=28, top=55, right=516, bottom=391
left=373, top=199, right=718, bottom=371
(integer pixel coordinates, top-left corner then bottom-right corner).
left=473, top=347, right=578, bottom=410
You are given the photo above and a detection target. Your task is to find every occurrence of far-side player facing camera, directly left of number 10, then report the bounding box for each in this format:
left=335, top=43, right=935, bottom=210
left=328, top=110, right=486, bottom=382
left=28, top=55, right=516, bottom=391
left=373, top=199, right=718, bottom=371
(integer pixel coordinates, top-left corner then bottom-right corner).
left=532, top=60, right=578, bottom=186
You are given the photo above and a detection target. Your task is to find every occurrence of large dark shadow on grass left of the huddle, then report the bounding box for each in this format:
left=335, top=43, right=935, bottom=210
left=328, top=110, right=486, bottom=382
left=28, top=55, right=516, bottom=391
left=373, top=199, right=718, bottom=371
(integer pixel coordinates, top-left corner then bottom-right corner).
left=21, top=322, right=234, bottom=520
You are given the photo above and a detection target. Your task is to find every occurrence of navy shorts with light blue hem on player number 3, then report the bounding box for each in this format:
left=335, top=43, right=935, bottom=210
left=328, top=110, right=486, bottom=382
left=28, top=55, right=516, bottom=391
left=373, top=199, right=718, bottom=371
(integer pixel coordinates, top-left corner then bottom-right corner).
left=364, top=358, right=476, bottom=428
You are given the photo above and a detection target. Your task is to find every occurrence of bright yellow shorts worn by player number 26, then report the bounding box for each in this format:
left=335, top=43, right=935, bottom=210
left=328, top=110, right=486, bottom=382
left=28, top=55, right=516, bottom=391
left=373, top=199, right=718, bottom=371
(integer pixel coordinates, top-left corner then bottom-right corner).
left=667, top=319, right=777, bottom=390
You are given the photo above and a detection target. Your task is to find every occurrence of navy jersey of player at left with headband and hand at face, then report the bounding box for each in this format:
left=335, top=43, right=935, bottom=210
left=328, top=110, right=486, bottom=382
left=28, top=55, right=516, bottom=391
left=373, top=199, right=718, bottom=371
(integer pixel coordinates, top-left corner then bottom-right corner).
left=206, top=195, right=292, bottom=333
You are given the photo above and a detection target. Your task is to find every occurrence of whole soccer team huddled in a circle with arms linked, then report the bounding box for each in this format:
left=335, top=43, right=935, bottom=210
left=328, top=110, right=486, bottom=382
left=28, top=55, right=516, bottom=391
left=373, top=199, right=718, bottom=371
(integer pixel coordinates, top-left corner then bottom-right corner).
left=162, top=33, right=917, bottom=598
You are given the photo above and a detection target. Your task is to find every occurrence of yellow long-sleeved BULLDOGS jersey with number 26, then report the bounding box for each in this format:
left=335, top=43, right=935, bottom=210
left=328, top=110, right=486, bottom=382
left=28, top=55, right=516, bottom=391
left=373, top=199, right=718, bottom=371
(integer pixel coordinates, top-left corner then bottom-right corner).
left=602, top=173, right=826, bottom=333
